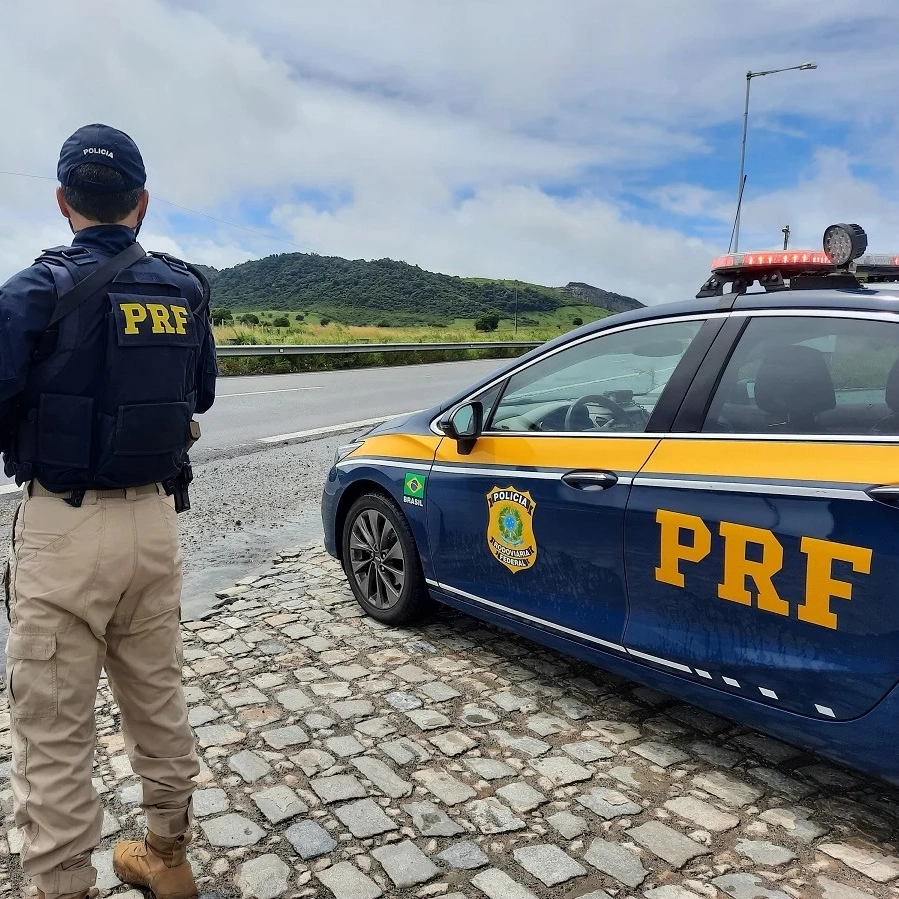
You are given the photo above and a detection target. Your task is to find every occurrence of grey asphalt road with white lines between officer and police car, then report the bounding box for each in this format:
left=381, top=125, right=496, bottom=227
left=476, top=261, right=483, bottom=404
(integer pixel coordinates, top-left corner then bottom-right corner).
left=0, top=361, right=503, bottom=670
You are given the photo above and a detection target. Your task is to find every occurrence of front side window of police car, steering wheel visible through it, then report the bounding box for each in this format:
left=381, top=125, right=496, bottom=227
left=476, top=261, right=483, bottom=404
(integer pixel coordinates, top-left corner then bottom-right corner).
left=488, top=321, right=703, bottom=432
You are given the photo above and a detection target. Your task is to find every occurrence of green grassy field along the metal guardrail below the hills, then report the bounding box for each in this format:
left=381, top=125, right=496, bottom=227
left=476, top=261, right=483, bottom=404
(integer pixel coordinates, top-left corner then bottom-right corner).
left=215, top=306, right=604, bottom=375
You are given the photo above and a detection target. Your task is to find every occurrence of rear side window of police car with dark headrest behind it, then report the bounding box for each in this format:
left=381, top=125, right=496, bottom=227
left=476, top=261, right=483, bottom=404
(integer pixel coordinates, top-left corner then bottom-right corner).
left=703, top=316, right=899, bottom=436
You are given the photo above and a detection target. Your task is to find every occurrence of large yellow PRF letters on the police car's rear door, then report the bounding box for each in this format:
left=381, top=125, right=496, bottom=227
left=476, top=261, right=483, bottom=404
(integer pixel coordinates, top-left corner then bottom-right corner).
left=655, top=509, right=872, bottom=630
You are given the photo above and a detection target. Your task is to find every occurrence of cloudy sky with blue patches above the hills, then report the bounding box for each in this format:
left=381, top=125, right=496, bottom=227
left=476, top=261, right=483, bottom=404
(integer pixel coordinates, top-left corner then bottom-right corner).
left=0, top=0, right=899, bottom=302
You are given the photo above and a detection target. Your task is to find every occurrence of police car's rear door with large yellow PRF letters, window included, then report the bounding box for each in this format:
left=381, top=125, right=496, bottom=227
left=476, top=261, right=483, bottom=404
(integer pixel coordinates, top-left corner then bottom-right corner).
left=624, top=309, right=899, bottom=720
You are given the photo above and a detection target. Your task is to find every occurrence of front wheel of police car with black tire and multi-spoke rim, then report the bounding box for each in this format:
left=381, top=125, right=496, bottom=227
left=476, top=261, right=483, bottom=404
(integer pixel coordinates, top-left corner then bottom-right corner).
left=341, top=493, right=430, bottom=624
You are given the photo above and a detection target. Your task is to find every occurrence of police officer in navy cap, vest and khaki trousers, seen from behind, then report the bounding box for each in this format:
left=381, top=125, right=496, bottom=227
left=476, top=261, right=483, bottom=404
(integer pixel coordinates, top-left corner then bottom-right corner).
left=0, top=125, right=217, bottom=899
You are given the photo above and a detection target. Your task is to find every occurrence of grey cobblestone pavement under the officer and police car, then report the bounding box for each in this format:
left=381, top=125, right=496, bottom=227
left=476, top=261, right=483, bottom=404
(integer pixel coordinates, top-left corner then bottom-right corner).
left=0, top=547, right=899, bottom=899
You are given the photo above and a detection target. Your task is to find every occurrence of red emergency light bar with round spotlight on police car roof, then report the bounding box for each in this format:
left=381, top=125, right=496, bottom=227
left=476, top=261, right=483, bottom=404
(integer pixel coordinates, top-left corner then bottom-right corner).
left=696, top=224, right=899, bottom=297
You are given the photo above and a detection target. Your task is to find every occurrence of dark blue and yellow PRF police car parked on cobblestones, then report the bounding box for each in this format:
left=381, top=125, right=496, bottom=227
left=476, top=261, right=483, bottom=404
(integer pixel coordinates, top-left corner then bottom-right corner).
left=322, top=225, right=899, bottom=783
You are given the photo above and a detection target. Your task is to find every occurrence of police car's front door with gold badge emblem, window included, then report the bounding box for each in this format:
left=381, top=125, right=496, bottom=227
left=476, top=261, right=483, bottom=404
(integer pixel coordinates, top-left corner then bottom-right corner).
left=427, top=316, right=720, bottom=649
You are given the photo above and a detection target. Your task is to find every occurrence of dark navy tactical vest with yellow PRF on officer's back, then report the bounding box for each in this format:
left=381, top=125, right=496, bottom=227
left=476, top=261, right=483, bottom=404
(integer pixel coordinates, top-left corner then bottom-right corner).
left=4, top=246, right=208, bottom=492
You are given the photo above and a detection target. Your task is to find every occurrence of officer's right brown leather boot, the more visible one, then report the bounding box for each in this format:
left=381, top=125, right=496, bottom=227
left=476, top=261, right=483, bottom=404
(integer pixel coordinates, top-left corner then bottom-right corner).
left=112, top=831, right=197, bottom=899
